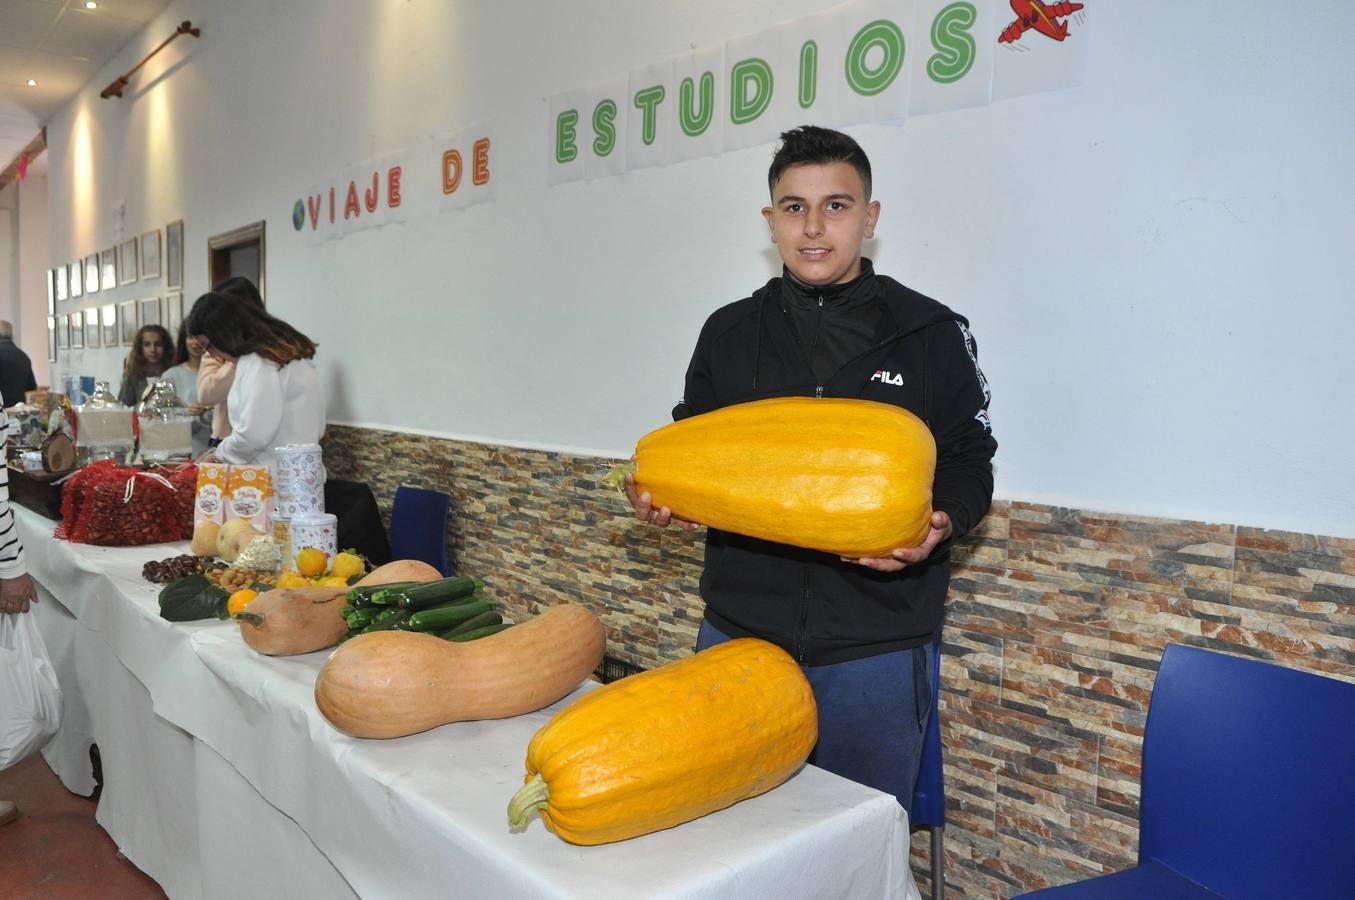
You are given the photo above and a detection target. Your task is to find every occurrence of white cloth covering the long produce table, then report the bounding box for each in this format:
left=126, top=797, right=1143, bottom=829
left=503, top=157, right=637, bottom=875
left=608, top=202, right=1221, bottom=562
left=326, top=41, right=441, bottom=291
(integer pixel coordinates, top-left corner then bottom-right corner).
left=15, top=507, right=920, bottom=900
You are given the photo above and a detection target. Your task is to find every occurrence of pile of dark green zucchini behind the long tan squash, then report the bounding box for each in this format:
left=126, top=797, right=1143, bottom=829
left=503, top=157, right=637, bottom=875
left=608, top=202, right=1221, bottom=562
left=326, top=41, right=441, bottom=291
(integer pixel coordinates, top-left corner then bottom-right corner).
left=339, top=575, right=511, bottom=644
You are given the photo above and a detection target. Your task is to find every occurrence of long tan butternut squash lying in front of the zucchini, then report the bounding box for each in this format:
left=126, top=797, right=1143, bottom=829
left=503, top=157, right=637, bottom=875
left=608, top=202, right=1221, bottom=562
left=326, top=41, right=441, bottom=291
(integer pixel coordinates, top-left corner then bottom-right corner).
left=316, top=603, right=606, bottom=737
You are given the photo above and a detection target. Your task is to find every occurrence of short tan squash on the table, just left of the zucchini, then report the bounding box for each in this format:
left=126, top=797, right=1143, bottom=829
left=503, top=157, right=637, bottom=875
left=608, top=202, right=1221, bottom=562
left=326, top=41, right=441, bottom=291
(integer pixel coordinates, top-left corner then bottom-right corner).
left=234, top=586, right=348, bottom=656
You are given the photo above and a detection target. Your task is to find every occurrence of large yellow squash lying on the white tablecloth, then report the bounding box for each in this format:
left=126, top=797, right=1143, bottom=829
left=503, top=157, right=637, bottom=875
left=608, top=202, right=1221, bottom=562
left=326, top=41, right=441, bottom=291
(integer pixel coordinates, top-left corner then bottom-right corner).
left=508, top=637, right=818, bottom=844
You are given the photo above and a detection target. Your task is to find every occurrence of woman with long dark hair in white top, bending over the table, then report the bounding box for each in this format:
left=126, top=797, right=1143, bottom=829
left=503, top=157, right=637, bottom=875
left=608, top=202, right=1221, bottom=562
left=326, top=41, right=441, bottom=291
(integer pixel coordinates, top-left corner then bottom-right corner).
left=184, top=291, right=325, bottom=465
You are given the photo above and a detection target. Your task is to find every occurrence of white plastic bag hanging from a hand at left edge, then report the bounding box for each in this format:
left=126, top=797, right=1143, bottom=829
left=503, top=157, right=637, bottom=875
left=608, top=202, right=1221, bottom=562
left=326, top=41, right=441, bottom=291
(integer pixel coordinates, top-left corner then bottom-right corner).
left=0, top=613, right=61, bottom=770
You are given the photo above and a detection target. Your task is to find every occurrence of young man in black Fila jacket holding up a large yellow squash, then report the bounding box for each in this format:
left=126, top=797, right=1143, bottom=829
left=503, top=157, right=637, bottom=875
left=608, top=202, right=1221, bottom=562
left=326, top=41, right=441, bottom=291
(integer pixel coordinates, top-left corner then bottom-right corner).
left=626, top=126, right=997, bottom=812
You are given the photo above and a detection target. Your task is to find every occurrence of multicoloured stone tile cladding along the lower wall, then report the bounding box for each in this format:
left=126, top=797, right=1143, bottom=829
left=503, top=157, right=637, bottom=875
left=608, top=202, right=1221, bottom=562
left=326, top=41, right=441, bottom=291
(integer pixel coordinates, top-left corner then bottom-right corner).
left=325, top=426, right=1355, bottom=897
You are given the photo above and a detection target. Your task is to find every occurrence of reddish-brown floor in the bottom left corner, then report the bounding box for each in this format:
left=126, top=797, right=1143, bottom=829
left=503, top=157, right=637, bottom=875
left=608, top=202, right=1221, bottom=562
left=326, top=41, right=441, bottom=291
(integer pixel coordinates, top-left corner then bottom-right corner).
left=0, top=754, right=165, bottom=900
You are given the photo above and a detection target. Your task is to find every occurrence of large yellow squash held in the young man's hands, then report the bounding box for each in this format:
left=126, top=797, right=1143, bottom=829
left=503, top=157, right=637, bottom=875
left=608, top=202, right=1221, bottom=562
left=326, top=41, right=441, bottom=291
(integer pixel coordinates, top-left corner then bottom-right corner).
left=614, top=397, right=936, bottom=557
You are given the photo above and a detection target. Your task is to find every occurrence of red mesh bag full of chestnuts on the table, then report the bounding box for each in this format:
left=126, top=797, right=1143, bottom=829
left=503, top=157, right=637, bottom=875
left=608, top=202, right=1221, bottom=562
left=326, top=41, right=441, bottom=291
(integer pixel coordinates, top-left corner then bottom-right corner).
left=57, top=459, right=198, bottom=546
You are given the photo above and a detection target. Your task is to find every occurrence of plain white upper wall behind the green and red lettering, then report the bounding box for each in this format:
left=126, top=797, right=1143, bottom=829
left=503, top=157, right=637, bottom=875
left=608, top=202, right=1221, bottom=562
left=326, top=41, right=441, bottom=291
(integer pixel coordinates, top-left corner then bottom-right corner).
left=39, top=0, right=1355, bottom=535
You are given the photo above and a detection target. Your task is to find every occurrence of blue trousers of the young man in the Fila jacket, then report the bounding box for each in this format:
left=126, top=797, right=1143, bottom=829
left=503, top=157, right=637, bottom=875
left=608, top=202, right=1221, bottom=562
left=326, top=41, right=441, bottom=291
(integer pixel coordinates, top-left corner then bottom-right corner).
left=696, top=621, right=935, bottom=816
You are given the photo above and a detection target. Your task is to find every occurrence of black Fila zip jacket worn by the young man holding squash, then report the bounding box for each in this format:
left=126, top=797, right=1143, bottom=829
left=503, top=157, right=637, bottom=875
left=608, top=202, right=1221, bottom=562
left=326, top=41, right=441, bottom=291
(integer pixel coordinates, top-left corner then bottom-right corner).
left=673, top=260, right=997, bottom=666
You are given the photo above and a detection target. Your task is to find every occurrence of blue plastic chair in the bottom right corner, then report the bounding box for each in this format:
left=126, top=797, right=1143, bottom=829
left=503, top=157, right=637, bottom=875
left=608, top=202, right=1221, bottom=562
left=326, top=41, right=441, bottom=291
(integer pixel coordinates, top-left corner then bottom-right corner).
left=1026, top=644, right=1355, bottom=900
